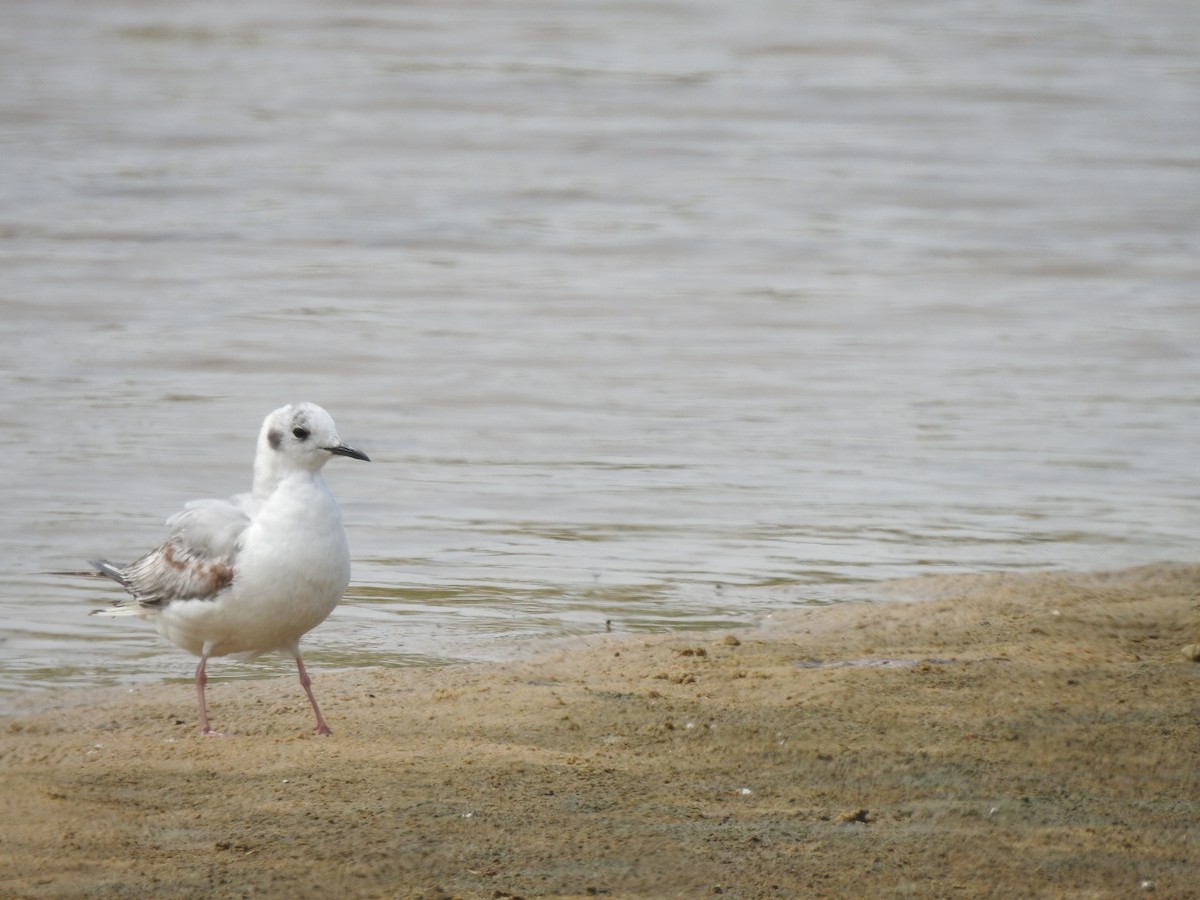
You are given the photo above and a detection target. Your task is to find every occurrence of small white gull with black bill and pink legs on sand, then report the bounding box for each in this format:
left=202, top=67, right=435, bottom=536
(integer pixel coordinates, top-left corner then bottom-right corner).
left=90, top=403, right=370, bottom=734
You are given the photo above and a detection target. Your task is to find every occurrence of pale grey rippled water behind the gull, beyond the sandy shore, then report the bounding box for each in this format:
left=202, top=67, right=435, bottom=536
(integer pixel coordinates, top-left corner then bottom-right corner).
left=0, top=0, right=1200, bottom=700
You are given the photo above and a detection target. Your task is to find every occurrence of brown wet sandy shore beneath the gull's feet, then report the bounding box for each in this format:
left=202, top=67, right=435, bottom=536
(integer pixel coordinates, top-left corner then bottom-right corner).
left=0, top=565, right=1200, bottom=899
